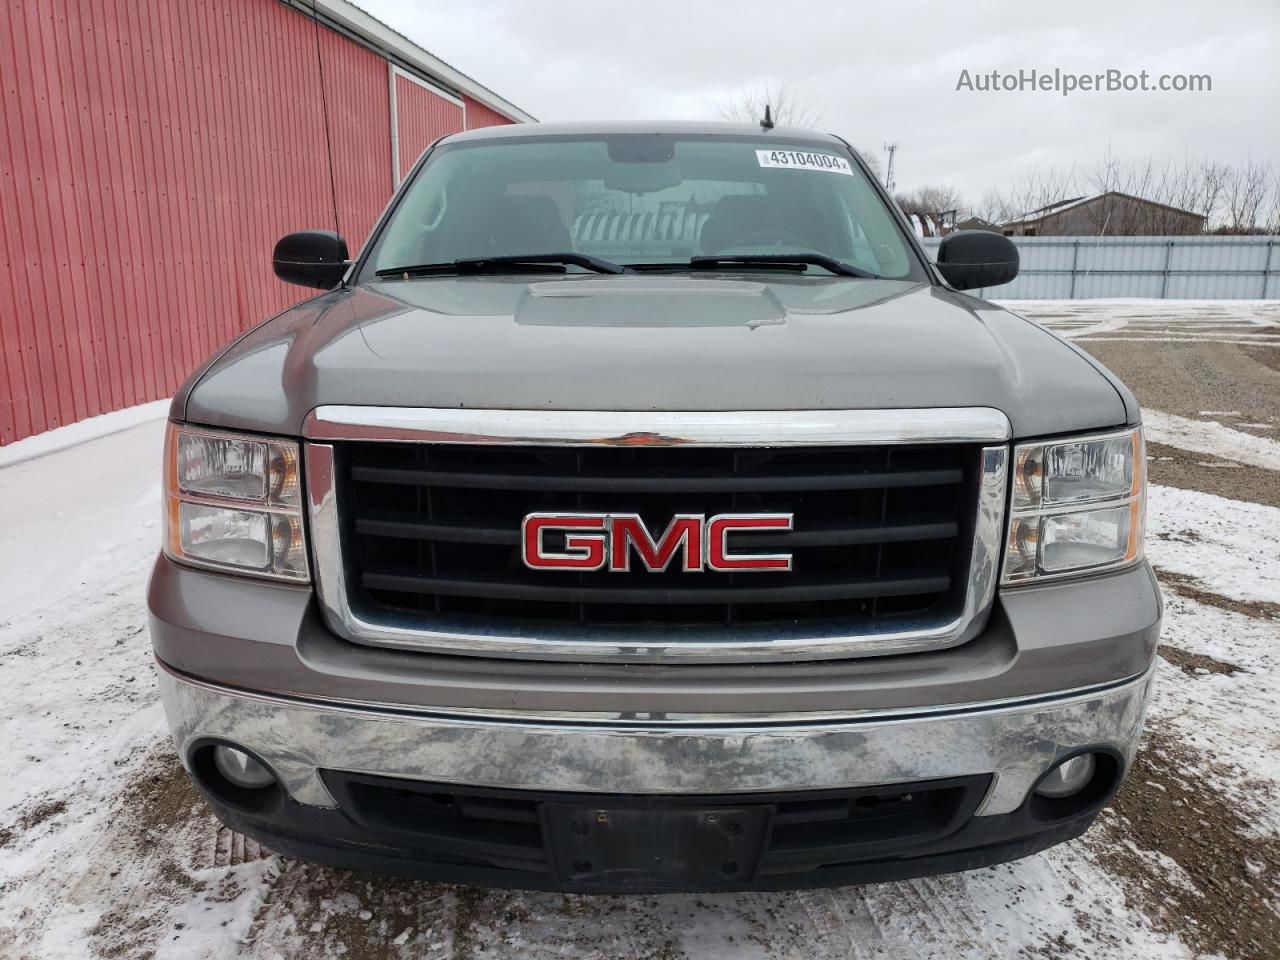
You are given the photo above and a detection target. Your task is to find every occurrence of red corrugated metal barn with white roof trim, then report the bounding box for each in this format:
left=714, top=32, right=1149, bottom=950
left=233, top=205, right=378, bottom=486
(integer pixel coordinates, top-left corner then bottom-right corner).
left=0, top=0, right=532, bottom=444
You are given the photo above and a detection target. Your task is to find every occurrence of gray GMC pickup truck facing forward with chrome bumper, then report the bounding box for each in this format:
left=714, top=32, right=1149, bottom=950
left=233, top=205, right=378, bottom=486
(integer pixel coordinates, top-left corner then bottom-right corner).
left=150, top=124, right=1161, bottom=892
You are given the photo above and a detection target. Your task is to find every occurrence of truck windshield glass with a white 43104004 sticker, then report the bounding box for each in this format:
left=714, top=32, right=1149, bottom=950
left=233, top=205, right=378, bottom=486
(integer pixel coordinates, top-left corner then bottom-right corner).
left=369, top=134, right=924, bottom=279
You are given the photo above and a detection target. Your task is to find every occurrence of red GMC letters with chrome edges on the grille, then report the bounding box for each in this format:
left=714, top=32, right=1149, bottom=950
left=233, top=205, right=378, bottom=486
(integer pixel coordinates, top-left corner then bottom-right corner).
left=521, top=513, right=792, bottom=573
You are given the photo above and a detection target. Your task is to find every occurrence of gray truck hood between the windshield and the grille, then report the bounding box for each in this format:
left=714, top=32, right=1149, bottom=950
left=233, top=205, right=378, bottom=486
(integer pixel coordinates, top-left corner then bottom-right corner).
left=173, top=275, right=1137, bottom=436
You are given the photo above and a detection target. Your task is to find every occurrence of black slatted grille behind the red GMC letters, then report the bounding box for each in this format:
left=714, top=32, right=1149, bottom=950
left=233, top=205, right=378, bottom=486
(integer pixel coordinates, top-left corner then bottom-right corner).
left=337, top=442, right=979, bottom=640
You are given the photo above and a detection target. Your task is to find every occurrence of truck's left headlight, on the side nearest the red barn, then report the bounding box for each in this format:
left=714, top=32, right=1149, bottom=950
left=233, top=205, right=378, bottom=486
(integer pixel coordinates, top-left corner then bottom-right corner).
left=164, top=424, right=311, bottom=581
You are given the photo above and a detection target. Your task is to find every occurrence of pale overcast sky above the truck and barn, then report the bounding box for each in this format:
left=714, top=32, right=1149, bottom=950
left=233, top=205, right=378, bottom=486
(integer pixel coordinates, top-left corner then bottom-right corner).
left=357, top=0, right=1280, bottom=209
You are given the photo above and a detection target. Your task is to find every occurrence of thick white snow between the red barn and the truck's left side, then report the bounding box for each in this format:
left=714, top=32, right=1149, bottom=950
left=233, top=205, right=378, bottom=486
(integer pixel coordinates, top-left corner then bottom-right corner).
left=0, top=421, right=175, bottom=957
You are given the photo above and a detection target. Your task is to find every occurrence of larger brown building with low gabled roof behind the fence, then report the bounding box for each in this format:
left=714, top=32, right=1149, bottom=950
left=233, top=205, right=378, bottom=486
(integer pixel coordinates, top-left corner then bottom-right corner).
left=1000, top=191, right=1204, bottom=237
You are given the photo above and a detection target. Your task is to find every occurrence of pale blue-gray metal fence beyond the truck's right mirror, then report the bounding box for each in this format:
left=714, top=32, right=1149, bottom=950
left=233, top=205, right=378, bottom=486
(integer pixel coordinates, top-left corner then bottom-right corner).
left=922, top=237, right=1280, bottom=300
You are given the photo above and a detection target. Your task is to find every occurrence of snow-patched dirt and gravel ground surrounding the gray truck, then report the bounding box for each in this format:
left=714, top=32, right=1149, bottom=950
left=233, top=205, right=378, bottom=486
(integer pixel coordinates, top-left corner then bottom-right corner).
left=0, top=301, right=1280, bottom=960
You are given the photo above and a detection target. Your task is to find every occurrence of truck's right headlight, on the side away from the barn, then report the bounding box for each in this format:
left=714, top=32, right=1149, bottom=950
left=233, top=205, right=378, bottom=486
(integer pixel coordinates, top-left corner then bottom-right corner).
left=1001, top=428, right=1147, bottom=585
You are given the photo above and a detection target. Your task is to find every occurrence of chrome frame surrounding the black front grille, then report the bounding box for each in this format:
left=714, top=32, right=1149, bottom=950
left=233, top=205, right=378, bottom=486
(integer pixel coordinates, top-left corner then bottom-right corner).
left=303, top=407, right=1011, bottom=663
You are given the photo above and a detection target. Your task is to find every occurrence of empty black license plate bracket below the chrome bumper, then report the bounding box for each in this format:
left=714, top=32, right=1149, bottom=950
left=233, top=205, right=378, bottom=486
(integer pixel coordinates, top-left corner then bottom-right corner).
left=541, top=803, right=773, bottom=888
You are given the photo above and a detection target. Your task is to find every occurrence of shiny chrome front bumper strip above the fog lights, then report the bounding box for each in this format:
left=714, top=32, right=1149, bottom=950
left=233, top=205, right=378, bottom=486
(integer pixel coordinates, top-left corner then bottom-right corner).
left=159, top=663, right=1151, bottom=815
